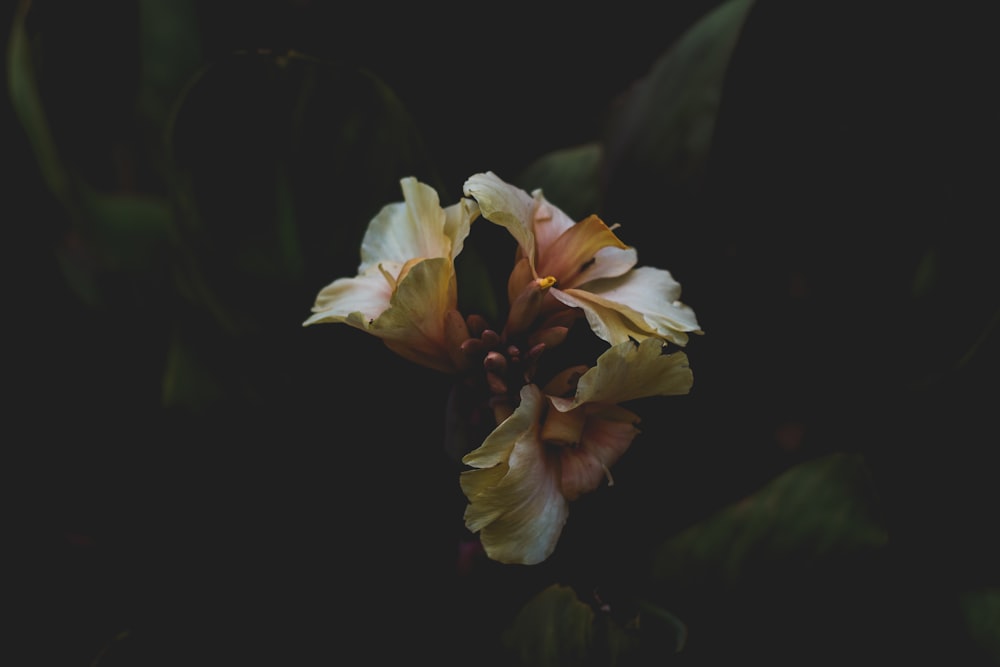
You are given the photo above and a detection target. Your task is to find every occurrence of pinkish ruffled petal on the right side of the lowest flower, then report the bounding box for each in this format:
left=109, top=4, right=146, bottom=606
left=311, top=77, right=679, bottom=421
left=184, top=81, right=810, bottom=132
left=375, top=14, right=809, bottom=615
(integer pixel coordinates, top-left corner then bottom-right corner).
left=560, top=405, right=639, bottom=501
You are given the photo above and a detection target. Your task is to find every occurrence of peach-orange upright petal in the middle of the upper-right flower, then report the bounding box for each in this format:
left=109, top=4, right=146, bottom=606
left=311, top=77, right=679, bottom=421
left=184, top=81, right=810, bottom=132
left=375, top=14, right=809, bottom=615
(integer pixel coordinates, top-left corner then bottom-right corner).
left=535, top=215, right=635, bottom=289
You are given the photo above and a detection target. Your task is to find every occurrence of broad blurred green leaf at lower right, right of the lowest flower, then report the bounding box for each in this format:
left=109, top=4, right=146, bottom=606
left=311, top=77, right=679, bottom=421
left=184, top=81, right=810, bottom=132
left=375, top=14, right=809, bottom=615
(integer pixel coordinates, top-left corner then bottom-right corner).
left=653, top=454, right=888, bottom=584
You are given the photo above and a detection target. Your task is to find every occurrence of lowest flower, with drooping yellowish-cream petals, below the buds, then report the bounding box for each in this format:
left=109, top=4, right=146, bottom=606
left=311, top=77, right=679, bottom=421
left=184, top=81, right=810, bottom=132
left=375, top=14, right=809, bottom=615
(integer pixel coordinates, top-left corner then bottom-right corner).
left=460, top=337, right=693, bottom=565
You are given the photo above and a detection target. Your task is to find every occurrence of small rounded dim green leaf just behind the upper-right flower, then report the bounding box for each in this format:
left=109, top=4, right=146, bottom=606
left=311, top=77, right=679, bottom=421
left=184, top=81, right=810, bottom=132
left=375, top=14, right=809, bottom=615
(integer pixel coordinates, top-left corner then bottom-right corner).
left=517, top=143, right=603, bottom=220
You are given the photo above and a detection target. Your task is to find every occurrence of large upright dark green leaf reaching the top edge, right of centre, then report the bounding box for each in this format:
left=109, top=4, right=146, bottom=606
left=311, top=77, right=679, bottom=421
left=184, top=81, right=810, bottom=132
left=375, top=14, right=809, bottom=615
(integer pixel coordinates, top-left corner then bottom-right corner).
left=606, top=0, right=753, bottom=194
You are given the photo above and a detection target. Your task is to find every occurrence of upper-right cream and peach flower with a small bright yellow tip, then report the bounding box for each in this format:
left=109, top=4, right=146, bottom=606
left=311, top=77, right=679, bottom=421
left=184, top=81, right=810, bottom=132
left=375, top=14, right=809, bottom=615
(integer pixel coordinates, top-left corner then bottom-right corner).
left=464, top=172, right=702, bottom=346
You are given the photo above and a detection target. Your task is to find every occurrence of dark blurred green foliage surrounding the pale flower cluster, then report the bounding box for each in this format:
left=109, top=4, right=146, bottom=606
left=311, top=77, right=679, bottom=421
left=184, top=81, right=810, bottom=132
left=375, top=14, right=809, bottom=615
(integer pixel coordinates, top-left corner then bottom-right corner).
left=3, top=0, right=1000, bottom=667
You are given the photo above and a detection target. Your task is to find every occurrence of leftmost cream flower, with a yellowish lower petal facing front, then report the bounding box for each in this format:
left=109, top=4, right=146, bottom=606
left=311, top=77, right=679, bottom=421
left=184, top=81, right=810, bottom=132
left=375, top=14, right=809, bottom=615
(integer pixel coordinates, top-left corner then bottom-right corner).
left=303, top=177, right=479, bottom=373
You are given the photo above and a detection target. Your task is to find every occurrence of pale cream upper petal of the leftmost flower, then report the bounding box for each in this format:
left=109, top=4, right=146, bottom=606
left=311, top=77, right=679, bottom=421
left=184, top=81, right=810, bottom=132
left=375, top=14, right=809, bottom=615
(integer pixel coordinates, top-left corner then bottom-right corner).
left=358, top=177, right=457, bottom=273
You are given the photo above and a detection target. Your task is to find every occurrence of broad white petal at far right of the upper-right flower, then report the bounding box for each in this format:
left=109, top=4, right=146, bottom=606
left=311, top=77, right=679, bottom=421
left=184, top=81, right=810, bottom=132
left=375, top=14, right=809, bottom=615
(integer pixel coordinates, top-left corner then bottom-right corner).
left=552, top=266, right=701, bottom=346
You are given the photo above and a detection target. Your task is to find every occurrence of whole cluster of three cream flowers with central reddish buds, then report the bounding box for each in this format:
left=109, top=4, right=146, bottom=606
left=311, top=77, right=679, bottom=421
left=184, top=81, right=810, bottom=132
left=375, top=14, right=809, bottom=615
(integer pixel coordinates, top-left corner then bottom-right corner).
left=304, top=172, right=701, bottom=564
